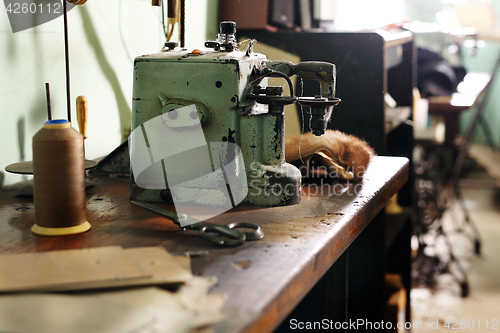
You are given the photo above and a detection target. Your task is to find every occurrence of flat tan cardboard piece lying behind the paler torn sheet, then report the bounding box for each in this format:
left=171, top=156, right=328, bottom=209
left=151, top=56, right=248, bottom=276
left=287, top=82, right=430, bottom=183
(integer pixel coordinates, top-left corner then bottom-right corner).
left=0, top=246, right=192, bottom=292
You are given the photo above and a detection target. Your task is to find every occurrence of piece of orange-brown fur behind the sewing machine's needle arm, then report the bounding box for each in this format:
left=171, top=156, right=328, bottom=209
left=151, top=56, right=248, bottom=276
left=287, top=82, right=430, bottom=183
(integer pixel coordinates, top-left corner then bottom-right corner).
left=285, top=130, right=375, bottom=181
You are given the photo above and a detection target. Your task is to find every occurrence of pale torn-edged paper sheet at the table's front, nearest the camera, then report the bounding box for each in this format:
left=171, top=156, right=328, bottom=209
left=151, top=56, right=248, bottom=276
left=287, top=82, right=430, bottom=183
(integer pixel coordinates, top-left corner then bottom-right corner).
left=0, top=277, right=225, bottom=333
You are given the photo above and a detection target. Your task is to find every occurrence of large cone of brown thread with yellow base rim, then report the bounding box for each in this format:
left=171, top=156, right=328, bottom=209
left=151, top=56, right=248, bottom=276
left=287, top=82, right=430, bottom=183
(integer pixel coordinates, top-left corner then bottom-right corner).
left=31, top=119, right=90, bottom=236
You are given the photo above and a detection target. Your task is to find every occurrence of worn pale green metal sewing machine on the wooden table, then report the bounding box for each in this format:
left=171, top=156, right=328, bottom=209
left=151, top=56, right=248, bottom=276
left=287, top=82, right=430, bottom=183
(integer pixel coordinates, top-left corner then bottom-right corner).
left=129, top=22, right=340, bottom=223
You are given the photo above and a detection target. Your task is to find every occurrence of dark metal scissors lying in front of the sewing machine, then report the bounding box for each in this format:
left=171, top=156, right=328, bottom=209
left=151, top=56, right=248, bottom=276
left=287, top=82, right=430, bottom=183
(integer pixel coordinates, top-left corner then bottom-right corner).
left=131, top=200, right=264, bottom=247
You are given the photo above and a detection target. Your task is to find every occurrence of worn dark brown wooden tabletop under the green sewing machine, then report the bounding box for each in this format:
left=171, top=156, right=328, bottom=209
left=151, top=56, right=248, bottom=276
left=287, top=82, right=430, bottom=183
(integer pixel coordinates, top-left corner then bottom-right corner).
left=0, top=157, right=409, bottom=332
